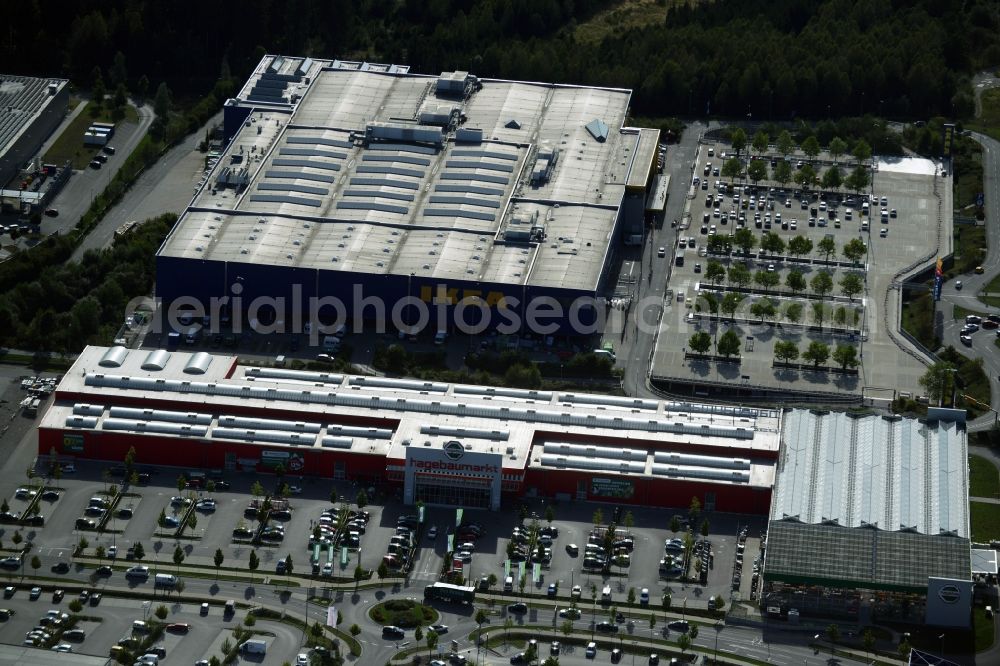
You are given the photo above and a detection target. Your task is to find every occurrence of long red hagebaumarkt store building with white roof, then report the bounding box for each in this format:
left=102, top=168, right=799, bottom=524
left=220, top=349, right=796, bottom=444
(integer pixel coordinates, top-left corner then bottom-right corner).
left=38, top=347, right=781, bottom=515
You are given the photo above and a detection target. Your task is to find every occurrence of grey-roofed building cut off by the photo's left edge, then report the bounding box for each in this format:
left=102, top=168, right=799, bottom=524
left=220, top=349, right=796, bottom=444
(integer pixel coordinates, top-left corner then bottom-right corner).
left=0, top=74, right=69, bottom=207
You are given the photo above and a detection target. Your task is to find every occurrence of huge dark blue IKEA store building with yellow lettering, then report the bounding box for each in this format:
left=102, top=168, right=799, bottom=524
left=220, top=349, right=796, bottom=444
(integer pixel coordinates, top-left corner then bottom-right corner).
left=156, top=56, right=665, bottom=335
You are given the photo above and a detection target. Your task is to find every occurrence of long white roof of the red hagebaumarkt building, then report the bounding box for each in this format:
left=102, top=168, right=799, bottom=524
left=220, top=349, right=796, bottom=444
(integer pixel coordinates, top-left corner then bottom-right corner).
left=40, top=346, right=781, bottom=487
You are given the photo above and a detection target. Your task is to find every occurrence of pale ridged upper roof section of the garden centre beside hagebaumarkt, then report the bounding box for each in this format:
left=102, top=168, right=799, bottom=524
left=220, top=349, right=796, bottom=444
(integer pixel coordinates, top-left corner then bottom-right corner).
left=771, top=410, right=969, bottom=537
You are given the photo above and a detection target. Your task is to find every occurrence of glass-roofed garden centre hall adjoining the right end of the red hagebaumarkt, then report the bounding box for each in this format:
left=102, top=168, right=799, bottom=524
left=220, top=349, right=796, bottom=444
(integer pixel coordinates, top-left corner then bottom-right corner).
left=761, top=409, right=973, bottom=627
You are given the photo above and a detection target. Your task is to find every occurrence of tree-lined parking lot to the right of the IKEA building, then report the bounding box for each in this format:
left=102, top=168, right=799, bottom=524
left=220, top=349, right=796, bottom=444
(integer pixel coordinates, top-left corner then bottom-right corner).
left=653, top=139, right=950, bottom=394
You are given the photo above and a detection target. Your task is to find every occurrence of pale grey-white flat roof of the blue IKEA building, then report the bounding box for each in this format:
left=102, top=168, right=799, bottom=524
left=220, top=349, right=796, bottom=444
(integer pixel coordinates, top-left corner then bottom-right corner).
left=160, top=56, right=658, bottom=290
